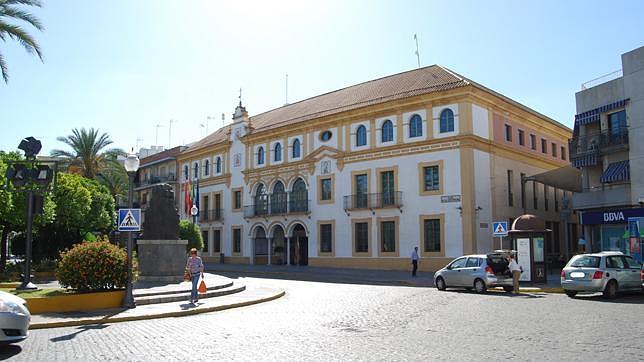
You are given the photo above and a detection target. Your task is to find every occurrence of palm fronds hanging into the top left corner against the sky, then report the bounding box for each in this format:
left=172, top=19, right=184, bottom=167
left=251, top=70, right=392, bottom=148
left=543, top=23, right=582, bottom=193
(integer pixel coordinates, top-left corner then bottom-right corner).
left=0, top=0, right=44, bottom=83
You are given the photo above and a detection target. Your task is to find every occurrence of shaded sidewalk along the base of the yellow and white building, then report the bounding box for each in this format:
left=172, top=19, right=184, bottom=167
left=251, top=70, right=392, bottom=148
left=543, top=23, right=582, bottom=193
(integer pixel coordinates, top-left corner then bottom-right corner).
left=206, top=263, right=562, bottom=292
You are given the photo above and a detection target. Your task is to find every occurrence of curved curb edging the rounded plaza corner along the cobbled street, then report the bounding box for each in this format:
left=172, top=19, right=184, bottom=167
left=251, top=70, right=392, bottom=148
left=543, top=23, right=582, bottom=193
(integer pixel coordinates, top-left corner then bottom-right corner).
left=29, top=291, right=286, bottom=330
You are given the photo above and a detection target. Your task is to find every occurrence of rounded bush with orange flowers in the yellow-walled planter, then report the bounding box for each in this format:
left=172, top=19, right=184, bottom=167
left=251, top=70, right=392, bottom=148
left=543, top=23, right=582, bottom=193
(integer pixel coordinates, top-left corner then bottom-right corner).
left=56, top=239, right=127, bottom=291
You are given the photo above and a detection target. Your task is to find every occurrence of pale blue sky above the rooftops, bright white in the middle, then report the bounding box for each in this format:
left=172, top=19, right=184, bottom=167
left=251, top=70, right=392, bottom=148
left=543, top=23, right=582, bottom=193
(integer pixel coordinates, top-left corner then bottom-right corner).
left=0, top=0, right=644, bottom=155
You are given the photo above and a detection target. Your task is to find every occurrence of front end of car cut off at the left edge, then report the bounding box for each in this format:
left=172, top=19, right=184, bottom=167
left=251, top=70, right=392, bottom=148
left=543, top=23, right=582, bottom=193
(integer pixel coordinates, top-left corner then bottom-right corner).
left=0, top=291, right=31, bottom=344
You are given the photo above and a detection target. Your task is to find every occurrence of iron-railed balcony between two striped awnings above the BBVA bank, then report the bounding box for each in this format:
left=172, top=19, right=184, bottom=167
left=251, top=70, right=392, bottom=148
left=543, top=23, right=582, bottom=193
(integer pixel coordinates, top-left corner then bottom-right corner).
left=568, top=127, right=628, bottom=161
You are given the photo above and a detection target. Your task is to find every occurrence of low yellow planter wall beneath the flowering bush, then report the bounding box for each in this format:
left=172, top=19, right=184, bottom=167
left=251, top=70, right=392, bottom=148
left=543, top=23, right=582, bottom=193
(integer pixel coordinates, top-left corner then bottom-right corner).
left=25, top=290, right=125, bottom=314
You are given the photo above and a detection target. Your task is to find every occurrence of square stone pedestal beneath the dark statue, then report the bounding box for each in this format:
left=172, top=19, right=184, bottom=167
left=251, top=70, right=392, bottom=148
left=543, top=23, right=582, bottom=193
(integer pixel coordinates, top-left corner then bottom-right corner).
left=136, top=240, right=188, bottom=283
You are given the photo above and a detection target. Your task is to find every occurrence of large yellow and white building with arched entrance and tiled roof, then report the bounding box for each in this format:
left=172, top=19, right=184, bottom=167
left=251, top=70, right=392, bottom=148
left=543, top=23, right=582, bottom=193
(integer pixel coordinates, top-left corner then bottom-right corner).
left=178, top=65, right=571, bottom=270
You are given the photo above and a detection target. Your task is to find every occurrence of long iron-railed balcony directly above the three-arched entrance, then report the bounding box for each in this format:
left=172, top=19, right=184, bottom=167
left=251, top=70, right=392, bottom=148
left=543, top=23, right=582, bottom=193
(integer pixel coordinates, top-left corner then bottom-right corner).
left=244, top=193, right=311, bottom=218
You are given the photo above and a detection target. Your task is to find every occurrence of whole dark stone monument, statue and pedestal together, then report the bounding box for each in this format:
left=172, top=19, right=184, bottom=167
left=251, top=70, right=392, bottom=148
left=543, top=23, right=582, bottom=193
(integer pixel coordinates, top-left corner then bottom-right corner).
left=137, top=184, right=188, bottom=282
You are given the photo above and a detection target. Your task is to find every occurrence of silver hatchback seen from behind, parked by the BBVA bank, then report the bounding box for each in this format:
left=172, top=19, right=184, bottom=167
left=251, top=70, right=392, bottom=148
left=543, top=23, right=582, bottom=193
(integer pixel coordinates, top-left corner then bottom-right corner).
left=561, top=251, right=642, bottom=298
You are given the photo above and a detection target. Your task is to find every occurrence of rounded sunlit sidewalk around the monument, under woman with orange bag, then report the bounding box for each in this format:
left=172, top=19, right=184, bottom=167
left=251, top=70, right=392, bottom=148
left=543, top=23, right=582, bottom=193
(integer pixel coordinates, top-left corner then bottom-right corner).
left=29, top=273, right=285, bottom=329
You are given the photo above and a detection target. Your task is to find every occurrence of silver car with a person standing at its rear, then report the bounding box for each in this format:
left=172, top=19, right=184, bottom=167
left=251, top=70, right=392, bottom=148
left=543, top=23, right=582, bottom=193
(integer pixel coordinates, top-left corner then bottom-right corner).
left=434, top=250, right=513, bottom=293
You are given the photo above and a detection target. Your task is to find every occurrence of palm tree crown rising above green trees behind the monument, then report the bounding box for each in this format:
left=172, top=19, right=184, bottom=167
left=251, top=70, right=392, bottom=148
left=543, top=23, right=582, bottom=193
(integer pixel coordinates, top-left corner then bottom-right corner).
left=52, top=126, right=125, bottom=179
